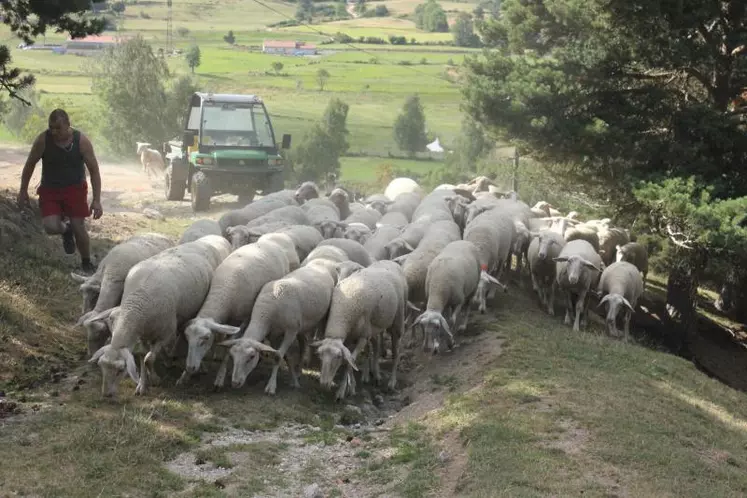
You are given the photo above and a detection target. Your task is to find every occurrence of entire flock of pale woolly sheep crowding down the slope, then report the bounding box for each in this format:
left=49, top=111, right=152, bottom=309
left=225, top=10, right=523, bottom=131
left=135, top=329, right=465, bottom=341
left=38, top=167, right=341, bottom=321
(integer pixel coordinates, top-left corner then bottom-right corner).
left=72, top=177, right=647, bottom=399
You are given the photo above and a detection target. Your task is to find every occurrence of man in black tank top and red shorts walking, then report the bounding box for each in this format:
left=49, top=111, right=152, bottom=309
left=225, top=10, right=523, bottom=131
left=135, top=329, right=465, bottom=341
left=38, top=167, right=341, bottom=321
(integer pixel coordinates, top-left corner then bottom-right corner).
left=18, top=109, right=103, bottom=274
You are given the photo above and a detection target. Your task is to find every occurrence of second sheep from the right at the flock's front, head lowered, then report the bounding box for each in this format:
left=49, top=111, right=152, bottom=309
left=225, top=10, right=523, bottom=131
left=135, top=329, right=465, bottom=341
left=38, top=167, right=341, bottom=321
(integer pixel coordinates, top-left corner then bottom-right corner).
left=553, top=239, right=602, bottom=332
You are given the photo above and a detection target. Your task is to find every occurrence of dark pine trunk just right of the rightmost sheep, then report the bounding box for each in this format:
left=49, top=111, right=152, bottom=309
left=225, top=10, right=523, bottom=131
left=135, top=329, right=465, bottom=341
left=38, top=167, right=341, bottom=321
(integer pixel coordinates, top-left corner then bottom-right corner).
left=667, top=249, right=706, bottom=356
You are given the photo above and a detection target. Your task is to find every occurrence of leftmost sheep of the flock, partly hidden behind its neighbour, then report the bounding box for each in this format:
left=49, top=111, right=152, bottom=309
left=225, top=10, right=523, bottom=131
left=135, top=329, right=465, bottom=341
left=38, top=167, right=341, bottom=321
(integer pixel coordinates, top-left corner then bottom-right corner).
left=70, top=233, right=174, bottom=357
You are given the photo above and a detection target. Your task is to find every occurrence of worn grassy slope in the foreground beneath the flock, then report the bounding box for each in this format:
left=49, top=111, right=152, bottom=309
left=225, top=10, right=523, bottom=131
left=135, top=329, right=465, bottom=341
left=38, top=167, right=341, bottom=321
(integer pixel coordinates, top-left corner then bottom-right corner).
left=0, top=194, right=747, bottom=497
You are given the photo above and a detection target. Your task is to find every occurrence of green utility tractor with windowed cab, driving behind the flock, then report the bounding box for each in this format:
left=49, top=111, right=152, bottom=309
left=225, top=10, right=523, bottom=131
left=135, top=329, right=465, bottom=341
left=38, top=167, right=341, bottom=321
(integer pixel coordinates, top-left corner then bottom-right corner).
left=163, top=92, right=291, bottom=212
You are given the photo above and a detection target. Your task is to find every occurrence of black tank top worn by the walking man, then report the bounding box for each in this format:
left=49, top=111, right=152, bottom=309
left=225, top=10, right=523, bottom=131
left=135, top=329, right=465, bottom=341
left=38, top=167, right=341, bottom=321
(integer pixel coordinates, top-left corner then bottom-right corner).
left=41, top=130, right=86, bottom=188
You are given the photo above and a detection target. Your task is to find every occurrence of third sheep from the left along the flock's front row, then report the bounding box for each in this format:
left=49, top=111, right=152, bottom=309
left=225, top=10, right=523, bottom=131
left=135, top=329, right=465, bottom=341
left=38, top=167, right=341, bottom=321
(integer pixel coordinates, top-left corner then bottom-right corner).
left=177, top=234, right=298, bottom=384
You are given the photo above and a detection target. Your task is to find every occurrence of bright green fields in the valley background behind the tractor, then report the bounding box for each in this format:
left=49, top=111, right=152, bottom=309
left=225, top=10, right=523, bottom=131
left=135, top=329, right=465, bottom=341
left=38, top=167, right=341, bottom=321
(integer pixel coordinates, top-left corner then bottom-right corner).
left=0, top=0, right=475, bottom=178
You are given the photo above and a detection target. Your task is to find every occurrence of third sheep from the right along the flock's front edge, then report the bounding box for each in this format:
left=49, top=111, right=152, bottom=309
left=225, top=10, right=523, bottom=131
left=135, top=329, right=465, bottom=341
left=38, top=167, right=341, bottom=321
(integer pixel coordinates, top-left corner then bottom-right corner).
left=527, top=230, right=566, bottom=316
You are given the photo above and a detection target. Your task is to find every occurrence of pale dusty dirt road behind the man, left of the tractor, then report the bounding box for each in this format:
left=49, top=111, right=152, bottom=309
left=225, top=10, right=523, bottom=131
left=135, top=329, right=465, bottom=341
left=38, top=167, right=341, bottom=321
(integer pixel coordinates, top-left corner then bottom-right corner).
left=0, top=145, right=238, bottom=218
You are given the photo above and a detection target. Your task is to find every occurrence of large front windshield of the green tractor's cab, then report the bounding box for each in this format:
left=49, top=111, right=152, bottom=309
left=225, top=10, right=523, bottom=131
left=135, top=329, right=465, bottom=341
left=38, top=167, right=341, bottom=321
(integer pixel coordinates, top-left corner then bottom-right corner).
left=202, top=103, right=275, bottom=147
